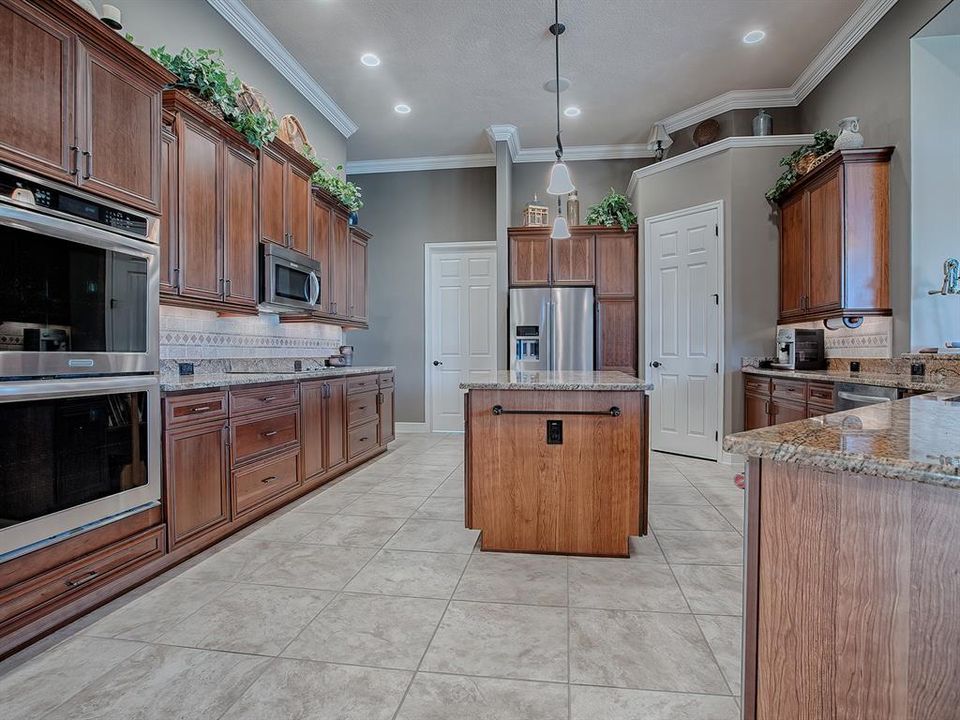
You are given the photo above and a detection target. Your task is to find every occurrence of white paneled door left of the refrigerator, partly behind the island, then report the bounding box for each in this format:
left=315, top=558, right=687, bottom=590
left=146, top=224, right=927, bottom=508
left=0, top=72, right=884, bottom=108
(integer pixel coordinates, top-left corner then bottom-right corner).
left=426, top=243, right=497, bottom=432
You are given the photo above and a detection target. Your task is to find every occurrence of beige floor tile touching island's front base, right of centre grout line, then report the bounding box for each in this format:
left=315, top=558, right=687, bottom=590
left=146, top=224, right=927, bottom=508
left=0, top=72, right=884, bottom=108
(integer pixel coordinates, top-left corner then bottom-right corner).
left=570, top=558, right=690, bottom=613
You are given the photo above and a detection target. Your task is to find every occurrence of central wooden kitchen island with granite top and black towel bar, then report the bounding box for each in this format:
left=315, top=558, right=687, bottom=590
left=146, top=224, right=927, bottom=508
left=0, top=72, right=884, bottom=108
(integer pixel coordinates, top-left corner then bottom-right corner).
left=460, top=371, right=652, bottom=557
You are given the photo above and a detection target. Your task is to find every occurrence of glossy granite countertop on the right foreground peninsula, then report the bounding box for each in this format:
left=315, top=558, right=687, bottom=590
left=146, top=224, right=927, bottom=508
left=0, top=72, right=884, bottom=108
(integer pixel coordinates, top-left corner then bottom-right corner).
left=723, top=390, right=960, bottom=490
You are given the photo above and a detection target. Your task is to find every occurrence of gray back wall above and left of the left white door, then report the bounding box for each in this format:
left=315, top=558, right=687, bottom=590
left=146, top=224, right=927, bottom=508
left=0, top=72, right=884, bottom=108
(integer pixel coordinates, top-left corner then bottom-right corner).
left=345, top=168, right=497, bottom=422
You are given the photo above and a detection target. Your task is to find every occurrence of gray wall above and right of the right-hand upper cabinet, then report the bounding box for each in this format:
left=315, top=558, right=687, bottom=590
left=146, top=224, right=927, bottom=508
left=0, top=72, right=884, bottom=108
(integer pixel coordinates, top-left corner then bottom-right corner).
left=800, top=0, right=947, bottom=352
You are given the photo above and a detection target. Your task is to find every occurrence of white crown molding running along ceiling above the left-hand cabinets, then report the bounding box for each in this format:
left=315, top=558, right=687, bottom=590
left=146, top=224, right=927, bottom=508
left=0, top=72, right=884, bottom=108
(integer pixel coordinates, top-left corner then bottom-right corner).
left=207, top=0, right=358, bottom=138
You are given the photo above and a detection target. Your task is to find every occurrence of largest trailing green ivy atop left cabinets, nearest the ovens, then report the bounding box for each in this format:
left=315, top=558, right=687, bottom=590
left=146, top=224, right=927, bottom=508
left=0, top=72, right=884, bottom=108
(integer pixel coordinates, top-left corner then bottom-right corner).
left=150, top=45, right=278, bottom=147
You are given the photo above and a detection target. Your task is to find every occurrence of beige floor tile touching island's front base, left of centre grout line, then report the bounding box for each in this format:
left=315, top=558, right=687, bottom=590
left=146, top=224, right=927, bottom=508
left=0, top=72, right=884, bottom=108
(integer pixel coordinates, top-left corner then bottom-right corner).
left=453, top=553, right=567, bottom=606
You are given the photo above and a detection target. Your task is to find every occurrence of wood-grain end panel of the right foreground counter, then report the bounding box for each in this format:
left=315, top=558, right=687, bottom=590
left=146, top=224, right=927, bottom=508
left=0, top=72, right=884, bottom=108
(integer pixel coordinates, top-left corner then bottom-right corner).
left=744, top=460, right=960, bottom=720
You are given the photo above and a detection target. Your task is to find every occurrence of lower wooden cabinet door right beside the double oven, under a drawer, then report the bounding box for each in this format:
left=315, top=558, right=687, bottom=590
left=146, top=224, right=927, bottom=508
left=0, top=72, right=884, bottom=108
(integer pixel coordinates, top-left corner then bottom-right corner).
left=163, top=422, right=230, bottom=548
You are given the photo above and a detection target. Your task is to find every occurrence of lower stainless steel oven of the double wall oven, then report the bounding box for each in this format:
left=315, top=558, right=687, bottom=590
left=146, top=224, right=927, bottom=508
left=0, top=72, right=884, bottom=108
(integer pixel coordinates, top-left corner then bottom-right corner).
left=0, top=375, right=160, bottom=562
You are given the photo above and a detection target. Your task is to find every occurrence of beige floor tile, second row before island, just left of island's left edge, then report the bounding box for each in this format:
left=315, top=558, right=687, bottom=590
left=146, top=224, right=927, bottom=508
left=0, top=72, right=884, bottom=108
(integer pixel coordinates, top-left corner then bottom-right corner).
left=283, top=594, right=447, bottom=670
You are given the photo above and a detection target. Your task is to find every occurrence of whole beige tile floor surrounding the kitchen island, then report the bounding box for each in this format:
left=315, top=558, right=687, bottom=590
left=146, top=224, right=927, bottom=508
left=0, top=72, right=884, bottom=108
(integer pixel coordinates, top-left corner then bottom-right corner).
left=0, top=435, right=743, bottom=720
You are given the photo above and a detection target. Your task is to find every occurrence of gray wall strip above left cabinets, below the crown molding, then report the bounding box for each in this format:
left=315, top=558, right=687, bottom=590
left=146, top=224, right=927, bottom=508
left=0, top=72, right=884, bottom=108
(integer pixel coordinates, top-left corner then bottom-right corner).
left=109, top=0, right=347, bottom=167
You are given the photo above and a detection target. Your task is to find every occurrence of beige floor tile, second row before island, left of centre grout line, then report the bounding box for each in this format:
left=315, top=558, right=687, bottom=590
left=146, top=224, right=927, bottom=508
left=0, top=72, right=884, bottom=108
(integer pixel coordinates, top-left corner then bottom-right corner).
left=420, top=601, right=567, bottom=682
